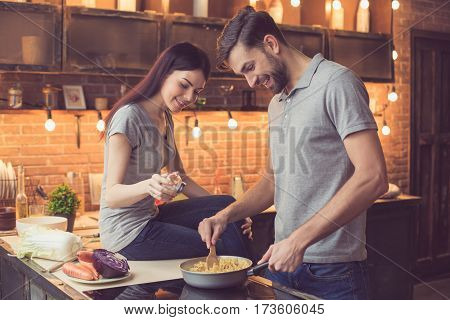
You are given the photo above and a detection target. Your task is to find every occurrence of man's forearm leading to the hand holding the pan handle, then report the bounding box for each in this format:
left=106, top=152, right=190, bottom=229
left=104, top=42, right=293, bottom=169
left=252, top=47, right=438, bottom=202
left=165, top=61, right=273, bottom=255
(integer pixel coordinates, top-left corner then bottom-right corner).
left=290, top=172, right=387, bottom=250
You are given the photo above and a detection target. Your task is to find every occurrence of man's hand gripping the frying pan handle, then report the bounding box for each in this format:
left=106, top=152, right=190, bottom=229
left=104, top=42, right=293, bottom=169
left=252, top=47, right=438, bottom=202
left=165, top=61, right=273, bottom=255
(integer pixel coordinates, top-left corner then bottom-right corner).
left=258, top=238, right=305, bottom=272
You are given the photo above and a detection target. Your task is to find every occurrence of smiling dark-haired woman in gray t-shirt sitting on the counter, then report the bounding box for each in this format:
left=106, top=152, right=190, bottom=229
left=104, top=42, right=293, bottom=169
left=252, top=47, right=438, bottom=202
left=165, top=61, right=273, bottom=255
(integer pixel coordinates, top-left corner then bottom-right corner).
left=100, top=43, right=251, bottom=260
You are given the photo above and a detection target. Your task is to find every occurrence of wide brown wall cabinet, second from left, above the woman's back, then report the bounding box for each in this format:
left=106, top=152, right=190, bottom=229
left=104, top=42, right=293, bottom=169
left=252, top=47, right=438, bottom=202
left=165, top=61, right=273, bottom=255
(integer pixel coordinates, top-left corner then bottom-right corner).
left=63, top=7, right=162, bottom=74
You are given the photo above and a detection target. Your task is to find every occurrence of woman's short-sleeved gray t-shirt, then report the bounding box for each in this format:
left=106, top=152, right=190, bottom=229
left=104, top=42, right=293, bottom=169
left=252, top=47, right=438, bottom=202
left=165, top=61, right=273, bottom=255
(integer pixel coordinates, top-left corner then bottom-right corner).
left=99, top=104, right=177, bottom=252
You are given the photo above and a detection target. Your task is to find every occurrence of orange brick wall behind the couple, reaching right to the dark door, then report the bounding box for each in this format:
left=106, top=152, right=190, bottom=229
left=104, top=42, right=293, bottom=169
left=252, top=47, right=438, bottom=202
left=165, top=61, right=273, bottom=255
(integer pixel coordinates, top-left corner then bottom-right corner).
left=0, top=0, right=450, bottom=209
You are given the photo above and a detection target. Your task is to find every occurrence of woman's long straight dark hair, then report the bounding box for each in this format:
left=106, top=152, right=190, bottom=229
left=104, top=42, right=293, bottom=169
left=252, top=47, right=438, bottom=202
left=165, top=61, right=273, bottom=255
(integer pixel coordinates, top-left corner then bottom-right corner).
left=101, top=42, right=211, bottom=138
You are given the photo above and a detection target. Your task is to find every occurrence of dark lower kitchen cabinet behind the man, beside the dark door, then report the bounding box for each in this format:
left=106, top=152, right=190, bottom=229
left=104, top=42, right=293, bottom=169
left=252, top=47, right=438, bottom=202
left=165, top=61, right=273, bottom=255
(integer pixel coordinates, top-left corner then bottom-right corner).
left=366, top=196, right=420, bottom=300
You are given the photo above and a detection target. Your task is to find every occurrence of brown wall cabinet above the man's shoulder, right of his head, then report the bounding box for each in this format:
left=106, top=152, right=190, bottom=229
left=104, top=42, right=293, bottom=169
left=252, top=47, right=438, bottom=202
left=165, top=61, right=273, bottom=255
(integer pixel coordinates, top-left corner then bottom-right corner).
left=328, top=30, right=394, bottom=82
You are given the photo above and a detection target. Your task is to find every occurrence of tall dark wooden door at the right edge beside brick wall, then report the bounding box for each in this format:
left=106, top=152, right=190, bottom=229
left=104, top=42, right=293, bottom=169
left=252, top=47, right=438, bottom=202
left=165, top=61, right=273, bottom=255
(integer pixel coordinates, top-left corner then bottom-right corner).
left=411, top=31, right=450, bottom=276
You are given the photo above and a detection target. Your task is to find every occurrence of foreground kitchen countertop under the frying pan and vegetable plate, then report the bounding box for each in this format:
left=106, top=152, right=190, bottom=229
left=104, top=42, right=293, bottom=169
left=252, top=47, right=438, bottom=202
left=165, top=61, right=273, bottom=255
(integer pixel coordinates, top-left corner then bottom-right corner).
left=0, top=229, right=312, bottom=300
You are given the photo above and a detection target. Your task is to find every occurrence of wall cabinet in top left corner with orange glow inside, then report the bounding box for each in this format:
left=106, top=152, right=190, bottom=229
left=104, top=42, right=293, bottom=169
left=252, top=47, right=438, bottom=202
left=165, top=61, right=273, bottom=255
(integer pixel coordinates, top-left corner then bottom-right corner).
left=0, top=1, right=62, bottom=71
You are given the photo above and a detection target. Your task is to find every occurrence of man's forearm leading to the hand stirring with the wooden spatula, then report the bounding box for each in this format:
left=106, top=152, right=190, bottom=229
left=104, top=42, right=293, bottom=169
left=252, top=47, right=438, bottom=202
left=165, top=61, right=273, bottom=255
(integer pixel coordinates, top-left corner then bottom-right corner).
left=219, top=174, right=275, bottom=222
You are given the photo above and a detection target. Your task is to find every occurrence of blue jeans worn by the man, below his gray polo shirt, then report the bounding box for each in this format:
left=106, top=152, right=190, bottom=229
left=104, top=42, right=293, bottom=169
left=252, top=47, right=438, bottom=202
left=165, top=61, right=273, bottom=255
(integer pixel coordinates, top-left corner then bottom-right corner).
left=265, top=261, right=369, bottom=300
